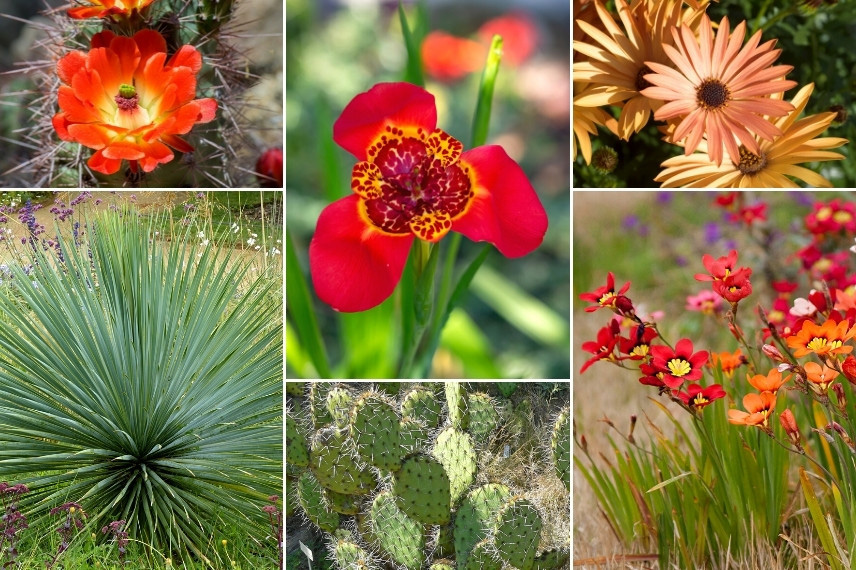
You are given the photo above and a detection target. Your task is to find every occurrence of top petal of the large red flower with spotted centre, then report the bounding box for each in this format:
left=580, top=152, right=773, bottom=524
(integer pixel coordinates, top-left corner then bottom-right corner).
left=333, top=83, right=437, bottom=160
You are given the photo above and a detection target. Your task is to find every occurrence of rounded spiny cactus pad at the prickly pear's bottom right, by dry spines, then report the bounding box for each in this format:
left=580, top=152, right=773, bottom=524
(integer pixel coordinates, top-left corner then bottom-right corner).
left=493, top=497, right=541, bottom=570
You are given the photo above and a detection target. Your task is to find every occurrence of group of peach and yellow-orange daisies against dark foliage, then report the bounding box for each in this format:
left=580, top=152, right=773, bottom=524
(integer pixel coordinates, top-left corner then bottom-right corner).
left=573, top=0, right=847, bottom=188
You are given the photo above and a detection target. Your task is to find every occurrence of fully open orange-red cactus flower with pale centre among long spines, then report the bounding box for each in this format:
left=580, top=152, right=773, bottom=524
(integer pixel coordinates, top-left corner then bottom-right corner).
left=53, top=30, right=217, bottom=174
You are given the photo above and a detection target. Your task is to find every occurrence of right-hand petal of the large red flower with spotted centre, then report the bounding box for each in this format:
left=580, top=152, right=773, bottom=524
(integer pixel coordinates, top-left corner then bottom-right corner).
left=452, top=145, right=547, bottom=257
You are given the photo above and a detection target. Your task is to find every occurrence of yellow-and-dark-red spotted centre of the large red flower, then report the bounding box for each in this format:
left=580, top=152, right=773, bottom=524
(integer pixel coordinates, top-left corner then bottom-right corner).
left=351, top=127, right=474, bottom=241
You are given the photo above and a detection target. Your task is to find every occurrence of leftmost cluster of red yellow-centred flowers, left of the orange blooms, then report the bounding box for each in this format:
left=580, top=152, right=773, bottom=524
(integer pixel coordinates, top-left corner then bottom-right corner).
left=580, top=272, right=725, bottom=413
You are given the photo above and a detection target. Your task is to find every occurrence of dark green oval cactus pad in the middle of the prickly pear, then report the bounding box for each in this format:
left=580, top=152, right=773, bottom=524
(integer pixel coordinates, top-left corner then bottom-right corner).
left=392, top=455, right=452, bottom=524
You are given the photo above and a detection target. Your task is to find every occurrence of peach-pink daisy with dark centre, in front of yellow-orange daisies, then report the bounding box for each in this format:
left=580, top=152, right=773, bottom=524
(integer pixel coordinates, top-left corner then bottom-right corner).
left=642, top=14, right=796, bottom=165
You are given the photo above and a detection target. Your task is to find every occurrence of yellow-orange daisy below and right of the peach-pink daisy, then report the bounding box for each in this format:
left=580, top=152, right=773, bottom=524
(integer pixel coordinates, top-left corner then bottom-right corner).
left=654, top=83, right=847, bottom=188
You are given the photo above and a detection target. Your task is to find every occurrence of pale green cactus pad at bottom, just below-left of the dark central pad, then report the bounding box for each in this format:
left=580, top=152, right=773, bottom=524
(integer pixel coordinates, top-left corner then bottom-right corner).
left=369, top=491, right=425, bottom=570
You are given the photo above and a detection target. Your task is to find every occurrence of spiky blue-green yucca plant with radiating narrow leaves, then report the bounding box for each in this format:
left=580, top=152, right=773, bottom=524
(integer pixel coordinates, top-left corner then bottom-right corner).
left=0, top=207, right=283, bottom=566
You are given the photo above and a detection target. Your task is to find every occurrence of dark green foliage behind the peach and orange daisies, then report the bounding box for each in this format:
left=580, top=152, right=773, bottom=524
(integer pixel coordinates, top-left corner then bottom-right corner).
left=573, top=0, right=856, bottom=188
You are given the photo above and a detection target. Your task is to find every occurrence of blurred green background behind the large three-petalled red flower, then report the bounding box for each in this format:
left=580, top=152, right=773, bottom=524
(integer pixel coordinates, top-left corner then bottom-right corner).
left=285, top=0, right=570, bottom=378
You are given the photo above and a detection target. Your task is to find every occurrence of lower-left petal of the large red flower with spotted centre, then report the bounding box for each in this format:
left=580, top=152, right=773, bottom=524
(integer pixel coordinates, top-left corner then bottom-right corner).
left=309, top=194, right=414, bottom=312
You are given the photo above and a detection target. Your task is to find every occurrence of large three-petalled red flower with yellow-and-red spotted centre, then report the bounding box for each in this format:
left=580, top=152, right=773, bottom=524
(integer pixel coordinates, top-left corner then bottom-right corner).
left=309, top=83, right=547, bottom=312
